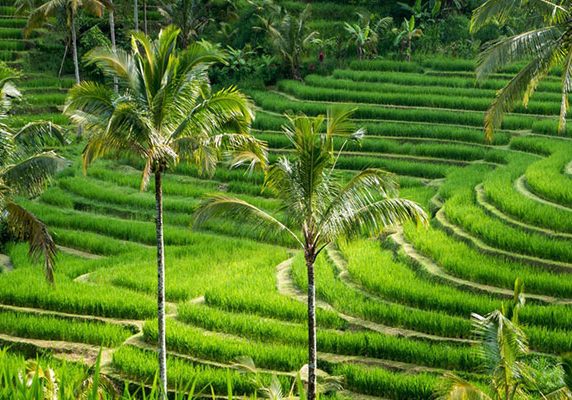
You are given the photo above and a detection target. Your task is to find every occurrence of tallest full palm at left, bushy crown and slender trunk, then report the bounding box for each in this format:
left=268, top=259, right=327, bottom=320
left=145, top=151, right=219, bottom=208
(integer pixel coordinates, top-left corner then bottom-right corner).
left=64, top=26, right=263, bottom=394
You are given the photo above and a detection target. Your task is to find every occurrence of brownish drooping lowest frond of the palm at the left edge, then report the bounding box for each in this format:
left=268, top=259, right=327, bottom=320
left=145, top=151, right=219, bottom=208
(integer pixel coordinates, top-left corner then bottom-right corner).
left=6, top=201, right=57, bottom=283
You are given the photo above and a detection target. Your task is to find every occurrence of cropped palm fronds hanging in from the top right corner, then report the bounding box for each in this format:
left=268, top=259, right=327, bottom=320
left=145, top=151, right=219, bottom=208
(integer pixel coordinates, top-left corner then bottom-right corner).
left=470, top=0, right=572, bottom=140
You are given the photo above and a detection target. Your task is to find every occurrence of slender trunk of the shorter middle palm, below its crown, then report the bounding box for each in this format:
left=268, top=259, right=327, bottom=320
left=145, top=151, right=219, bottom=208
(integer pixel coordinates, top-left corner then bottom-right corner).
left=306, top=254, right=318, bottom=400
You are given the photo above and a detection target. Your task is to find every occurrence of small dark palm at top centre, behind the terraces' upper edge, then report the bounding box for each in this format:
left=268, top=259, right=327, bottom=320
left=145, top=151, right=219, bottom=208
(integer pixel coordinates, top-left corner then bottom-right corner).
left=262, top=5, right=318, bottom=80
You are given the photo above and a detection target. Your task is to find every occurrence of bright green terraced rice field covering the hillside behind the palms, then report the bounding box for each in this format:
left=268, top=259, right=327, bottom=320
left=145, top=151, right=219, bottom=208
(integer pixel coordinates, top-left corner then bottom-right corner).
left=0, top=3, right=572, bottom=399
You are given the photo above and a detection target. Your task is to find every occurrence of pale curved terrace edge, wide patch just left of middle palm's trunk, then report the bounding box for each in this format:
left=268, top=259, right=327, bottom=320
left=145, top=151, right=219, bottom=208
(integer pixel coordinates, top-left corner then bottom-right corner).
left=276, top=258, right=475, bottom=344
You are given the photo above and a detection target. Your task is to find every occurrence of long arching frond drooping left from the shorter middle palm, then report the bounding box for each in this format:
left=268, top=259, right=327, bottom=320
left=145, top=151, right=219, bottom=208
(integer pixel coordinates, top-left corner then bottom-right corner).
left=193, top=195, right=303, bottom=247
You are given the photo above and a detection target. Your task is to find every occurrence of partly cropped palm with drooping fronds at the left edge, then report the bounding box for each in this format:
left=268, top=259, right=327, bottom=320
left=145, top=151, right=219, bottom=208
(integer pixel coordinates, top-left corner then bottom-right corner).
left=0, top=70, right=65, bottom=283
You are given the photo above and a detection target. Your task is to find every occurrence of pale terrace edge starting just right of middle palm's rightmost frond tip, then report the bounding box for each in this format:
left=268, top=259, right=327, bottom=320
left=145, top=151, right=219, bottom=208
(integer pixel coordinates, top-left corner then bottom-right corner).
left=435, top=209, right=572, bottom=272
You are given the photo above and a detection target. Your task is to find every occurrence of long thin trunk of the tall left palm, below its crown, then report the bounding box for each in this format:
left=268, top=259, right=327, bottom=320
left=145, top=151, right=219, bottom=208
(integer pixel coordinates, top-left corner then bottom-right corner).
left=155, top=171, right=167, bottom=399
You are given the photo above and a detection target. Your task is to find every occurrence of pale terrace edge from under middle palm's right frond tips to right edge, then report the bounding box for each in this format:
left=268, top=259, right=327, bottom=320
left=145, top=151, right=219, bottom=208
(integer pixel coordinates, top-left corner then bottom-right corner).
left=389, top=229, right=572, bottom=304
